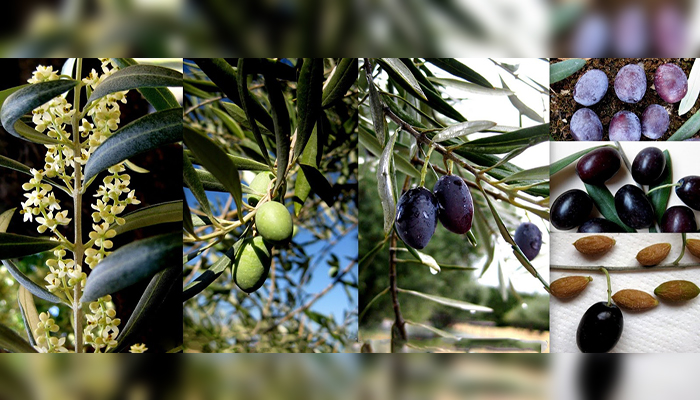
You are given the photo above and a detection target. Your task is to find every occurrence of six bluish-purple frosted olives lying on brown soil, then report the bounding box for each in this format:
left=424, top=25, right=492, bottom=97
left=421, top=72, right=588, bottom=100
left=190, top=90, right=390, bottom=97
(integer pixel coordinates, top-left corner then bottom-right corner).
left=570, top=64, right=688, bottom=141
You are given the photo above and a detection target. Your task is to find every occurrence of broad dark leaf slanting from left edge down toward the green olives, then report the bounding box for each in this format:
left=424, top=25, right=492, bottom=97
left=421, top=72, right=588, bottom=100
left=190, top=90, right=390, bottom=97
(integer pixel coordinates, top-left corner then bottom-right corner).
left=184, top=128, right=243, bottom=221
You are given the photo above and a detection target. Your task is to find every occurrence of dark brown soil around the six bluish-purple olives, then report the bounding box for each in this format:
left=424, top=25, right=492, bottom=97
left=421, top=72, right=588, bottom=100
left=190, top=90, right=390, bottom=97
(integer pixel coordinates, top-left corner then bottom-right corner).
left=549, top=58, right=700, bottom=141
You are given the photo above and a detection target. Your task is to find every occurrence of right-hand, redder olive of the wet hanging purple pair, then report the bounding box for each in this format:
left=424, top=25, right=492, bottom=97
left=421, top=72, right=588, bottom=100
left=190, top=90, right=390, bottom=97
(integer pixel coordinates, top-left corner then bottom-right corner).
left=433, top=175, right=474, bottom=235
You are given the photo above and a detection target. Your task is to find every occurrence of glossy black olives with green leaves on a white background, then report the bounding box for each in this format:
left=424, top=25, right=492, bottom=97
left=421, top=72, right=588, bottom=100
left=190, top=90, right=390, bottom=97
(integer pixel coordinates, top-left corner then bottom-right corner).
left=551, top=147, right=700, bottom=233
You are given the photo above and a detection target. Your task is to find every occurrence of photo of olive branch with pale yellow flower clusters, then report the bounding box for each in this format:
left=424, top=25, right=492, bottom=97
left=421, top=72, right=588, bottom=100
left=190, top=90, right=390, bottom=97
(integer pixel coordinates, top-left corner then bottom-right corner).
left=0, top=58, right=183, bottom=353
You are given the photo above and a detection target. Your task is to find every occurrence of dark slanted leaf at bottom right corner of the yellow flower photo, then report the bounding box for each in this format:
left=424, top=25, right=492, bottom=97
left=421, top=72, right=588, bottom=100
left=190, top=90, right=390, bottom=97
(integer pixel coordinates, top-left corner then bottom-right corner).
left=112, top=268, right=182, bottom=352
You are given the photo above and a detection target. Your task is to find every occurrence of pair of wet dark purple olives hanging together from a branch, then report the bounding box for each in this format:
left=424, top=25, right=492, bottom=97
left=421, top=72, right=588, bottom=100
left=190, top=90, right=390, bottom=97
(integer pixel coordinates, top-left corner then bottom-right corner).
left=396, top=175, right=474, bottom=249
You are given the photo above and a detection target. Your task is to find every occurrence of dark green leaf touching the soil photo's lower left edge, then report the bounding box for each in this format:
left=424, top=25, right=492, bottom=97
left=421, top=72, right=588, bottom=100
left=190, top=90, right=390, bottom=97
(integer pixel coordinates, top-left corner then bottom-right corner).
left=459, top=124, right=549, bottom=154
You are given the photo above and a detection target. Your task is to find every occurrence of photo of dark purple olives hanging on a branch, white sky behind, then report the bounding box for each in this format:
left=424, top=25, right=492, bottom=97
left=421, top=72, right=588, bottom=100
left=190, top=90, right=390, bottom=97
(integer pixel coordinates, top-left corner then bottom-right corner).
left=358, top=58, right=550, bottom=353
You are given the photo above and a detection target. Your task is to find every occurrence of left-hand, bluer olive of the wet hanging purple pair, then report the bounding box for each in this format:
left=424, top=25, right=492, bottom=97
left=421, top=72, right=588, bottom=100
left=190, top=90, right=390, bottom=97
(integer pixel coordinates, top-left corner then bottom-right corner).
left=396, top=187, right=438, bottom=249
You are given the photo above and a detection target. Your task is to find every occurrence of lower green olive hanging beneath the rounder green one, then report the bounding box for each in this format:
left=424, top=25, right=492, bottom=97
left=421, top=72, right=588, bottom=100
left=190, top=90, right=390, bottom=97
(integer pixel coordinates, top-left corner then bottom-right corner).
left=233, top=236, right=271, bottom=293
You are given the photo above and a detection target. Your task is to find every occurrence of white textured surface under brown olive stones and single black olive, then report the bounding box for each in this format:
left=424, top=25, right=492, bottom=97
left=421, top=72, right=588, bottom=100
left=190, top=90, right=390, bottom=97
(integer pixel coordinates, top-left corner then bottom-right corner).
left=550, top=232, right=700, bottom=353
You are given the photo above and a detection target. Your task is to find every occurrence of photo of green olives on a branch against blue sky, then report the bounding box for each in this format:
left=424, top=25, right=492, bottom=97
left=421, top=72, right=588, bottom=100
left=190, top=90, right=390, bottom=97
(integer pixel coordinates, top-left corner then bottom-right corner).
left=182, top=58, right=359, bottom=353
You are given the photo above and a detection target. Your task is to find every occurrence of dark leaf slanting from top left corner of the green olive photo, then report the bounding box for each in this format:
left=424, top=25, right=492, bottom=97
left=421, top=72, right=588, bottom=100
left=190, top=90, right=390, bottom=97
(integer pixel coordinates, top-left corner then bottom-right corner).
left=194, top=58, right=274, bottom=132
